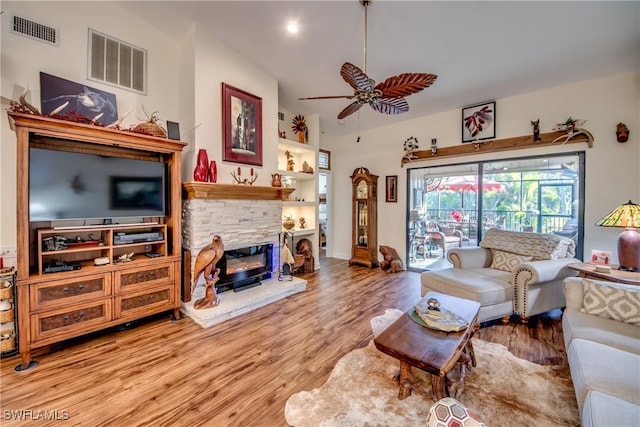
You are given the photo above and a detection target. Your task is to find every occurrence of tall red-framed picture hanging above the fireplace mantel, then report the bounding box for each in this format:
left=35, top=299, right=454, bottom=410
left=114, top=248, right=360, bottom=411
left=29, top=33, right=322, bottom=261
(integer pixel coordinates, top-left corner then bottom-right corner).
left=222, top=83, right=262, bottom=166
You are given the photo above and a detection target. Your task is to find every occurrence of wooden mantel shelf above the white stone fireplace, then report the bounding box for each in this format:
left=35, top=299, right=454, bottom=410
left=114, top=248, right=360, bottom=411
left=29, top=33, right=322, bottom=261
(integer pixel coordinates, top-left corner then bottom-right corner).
left=182, top=181, right=295, bottom=200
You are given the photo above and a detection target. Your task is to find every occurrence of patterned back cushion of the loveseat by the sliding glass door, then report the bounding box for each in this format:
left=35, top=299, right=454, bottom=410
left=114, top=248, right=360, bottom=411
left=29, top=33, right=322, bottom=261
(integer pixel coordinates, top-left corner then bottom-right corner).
left=480, top=228, right=575, bottom=260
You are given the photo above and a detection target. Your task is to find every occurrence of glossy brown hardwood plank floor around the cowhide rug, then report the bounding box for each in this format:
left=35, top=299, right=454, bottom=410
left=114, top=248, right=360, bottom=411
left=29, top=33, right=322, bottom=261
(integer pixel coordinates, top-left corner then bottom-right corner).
left=0, top=259, right=566, bottom=426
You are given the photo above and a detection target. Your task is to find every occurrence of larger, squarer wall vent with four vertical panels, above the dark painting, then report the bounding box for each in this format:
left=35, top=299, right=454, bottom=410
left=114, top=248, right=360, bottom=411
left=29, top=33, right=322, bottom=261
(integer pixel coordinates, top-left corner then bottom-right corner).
left=88, top=29, right=147, bottom=94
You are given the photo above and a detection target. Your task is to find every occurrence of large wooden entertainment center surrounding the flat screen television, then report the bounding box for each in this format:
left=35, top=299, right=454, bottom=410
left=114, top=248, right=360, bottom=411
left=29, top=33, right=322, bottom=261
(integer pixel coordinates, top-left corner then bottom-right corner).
left=9, top=112, right=186, bottom=371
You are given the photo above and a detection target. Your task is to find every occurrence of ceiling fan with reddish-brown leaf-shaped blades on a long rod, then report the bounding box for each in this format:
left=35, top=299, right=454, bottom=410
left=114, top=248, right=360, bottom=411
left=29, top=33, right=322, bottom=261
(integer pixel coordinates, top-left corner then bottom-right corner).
left=299, top=0, right=438, bottom=119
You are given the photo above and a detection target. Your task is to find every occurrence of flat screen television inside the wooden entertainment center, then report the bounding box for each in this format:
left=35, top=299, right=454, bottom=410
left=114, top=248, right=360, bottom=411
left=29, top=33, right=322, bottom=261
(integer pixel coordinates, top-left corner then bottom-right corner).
left=29, top=148, right=168, bottom=222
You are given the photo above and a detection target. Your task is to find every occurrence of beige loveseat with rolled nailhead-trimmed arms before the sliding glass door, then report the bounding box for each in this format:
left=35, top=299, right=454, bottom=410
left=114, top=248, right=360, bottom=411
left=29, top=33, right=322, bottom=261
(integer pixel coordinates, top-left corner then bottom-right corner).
left=421, top=228, right=580, bottom=322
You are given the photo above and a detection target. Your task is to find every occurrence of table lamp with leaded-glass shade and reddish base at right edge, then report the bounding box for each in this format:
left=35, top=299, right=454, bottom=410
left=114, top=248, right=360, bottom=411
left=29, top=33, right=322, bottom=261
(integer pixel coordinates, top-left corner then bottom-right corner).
left=596, top=200, right=640, bottom=271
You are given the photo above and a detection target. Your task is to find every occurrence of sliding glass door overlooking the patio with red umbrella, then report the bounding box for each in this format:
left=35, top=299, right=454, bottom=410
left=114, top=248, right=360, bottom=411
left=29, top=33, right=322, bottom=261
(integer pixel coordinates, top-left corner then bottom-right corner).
left=406, top=152, right=584, bottom=270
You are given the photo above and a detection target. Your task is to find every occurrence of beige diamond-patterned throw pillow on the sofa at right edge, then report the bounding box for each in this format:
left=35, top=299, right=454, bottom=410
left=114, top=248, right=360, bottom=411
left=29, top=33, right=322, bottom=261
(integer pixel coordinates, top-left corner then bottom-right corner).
left=580, top=279, right=640, bottom=326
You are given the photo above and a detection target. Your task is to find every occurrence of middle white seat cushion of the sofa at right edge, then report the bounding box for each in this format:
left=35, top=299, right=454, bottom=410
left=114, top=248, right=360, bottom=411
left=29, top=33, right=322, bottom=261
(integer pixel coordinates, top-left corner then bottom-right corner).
left=567, top=338, right=640, bottom=413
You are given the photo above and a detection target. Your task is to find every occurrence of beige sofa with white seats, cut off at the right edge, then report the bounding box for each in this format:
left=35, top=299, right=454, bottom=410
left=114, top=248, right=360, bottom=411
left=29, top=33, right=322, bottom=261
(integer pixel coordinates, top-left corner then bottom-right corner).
left=562, top=278, right=640, bottom=427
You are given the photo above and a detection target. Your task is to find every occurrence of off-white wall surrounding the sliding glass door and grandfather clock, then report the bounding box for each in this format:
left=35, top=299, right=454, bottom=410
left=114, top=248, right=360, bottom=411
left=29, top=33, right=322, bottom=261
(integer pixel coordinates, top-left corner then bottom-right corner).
left=322, top=73, right=640, bottom=261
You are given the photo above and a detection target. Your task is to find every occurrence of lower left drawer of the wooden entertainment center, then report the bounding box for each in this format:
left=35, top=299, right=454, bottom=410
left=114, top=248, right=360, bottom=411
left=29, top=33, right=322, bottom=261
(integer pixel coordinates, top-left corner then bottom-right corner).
left=31, top=299, right=113, bottom=341
